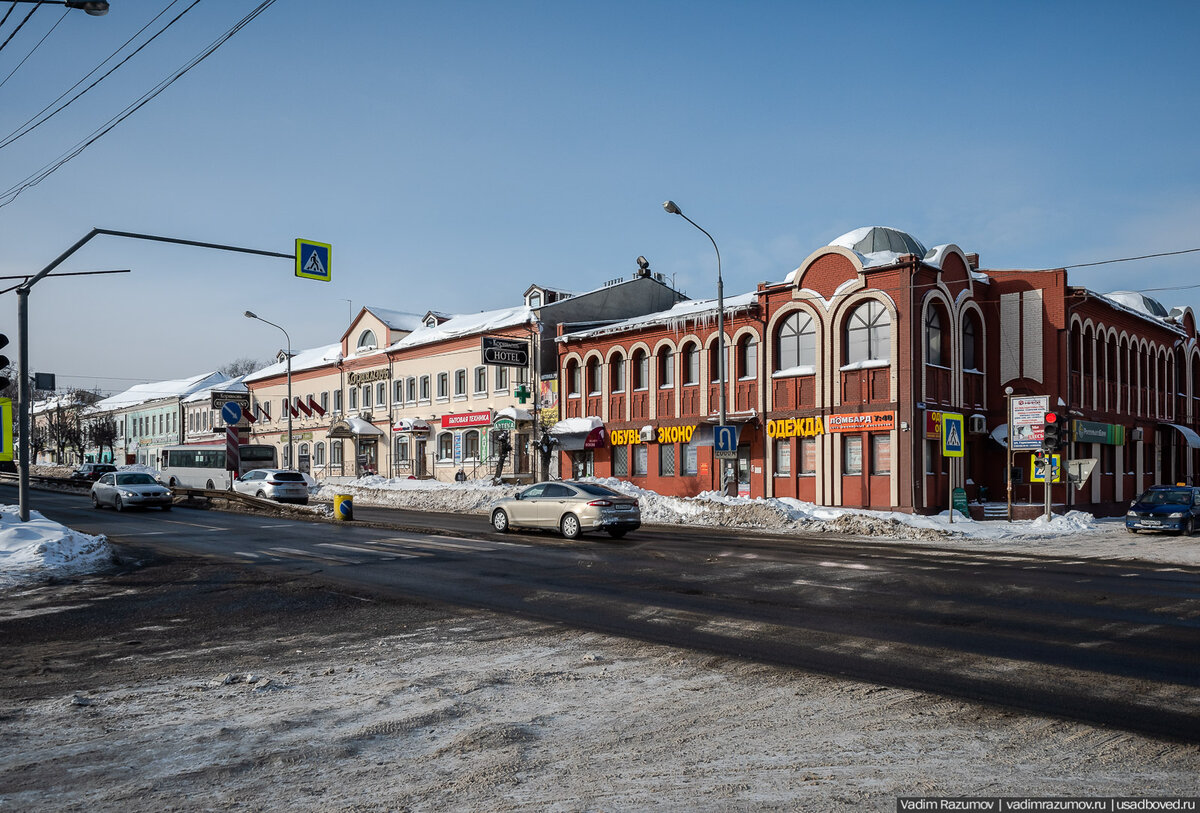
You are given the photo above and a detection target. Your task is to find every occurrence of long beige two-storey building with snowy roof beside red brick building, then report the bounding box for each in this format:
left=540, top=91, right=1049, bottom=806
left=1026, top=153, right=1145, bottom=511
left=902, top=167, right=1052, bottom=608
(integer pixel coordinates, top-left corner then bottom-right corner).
left=245, top=270, right=683, bottom=481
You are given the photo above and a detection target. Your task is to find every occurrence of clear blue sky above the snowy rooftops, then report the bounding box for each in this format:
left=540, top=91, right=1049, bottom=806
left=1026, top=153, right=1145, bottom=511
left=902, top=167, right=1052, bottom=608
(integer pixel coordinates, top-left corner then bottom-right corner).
left=0, top=0, right=1200, bottom=391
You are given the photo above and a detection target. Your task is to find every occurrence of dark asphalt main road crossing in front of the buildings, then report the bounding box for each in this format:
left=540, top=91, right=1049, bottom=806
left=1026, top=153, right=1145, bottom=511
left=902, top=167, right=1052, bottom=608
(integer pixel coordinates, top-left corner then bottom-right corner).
left=9, top=486, right=1200, bottom=741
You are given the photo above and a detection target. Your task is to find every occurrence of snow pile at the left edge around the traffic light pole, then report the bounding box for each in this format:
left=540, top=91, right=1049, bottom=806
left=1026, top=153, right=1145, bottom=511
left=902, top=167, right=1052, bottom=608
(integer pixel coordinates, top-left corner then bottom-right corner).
left=0, top=505, right=113, bottom=588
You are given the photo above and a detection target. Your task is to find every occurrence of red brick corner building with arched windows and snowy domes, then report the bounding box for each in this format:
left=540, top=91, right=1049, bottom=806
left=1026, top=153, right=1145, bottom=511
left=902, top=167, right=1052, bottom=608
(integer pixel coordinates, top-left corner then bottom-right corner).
left=559, top=227, right=1200, bottom=513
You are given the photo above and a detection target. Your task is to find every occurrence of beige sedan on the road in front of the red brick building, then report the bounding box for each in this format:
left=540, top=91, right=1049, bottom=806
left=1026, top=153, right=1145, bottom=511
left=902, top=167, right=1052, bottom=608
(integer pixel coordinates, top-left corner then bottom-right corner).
left=492, top=480, right=642, bottom=540
